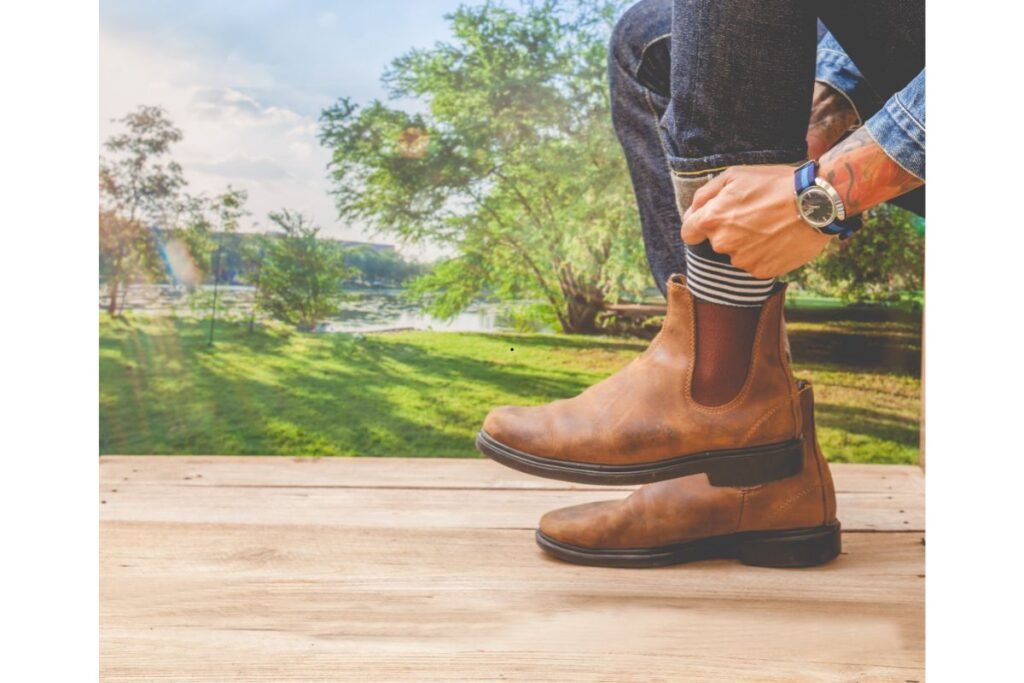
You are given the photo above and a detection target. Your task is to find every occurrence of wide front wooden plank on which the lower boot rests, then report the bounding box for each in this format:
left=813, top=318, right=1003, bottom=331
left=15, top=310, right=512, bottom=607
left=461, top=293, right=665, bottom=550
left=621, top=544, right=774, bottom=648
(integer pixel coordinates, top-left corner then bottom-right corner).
left=100, top=521, right=924, bottom=681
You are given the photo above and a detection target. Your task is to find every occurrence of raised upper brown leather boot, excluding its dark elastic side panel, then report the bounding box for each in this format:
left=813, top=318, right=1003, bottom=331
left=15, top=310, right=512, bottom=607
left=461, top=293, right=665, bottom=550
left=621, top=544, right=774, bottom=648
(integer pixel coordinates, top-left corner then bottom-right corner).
left=476, top=275, right=803, bottom=486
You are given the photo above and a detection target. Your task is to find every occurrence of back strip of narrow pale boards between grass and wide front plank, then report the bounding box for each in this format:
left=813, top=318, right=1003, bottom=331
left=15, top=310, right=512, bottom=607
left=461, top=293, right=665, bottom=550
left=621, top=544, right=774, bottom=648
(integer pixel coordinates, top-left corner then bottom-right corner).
left=99, top=457, right=925, bottom=531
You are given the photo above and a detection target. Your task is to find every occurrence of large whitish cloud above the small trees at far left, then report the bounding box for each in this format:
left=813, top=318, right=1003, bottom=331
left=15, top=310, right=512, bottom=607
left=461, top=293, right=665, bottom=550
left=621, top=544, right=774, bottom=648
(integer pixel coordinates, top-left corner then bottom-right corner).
left=99, top=31, right=344, bottom=240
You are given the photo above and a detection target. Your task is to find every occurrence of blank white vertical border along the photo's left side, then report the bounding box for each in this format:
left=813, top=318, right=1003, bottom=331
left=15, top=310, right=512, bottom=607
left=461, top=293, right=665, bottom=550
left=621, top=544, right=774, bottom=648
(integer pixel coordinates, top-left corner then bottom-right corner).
left=0, top=0, right=98, bottom=681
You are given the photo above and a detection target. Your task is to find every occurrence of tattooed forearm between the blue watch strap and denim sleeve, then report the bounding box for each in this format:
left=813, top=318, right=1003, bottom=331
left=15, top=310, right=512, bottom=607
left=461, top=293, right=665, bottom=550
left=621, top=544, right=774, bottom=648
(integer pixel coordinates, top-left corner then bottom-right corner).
left=818, top=127, right=925, bottom=215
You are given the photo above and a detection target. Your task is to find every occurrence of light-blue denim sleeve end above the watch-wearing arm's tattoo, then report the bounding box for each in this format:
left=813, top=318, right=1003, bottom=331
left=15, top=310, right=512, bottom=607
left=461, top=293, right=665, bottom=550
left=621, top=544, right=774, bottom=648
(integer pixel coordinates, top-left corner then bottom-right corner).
left=865, top=71, right=925, bottom=180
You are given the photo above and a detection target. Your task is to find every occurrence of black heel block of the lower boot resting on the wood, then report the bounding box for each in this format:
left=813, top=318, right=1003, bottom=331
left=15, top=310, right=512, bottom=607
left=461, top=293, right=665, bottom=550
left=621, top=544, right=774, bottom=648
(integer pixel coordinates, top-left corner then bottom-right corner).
left=736, top=521, right=843, bottom=567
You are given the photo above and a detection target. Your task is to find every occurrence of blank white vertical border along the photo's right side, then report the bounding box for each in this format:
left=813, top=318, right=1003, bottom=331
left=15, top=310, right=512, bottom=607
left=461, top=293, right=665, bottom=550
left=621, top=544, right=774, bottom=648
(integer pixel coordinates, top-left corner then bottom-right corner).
left=926, top=3, right=1024, bottom=683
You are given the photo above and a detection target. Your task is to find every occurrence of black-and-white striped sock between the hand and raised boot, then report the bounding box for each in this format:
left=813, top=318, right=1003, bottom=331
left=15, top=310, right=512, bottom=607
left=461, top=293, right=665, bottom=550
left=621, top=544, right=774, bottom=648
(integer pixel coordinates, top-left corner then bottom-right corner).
left=686, top=242, right=775, bottom=308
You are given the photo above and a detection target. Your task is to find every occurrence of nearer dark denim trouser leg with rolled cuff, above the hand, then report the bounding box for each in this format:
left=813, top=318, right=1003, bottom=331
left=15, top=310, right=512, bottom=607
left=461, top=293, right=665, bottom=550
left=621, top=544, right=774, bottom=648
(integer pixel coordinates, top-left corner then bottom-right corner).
left=662, top=0, right=817, bottom=179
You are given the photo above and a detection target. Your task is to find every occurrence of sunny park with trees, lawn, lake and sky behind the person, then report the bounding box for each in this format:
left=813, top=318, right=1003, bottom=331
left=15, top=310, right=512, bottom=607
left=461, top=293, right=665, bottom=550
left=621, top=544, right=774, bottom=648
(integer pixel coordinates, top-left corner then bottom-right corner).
left=98, top=0, right=924, bottom=463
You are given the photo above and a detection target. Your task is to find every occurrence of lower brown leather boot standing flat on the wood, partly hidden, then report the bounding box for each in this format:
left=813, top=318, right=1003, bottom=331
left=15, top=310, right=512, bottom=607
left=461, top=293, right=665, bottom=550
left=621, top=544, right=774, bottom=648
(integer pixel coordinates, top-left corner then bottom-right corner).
left=537, top=382, right=841, bottom=567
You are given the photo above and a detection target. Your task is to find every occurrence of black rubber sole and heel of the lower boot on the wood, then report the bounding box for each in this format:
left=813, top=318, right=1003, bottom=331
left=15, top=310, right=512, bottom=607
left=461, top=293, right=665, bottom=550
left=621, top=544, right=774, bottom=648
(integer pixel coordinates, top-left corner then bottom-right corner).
left=537, top=521, right=843, bottom=568
